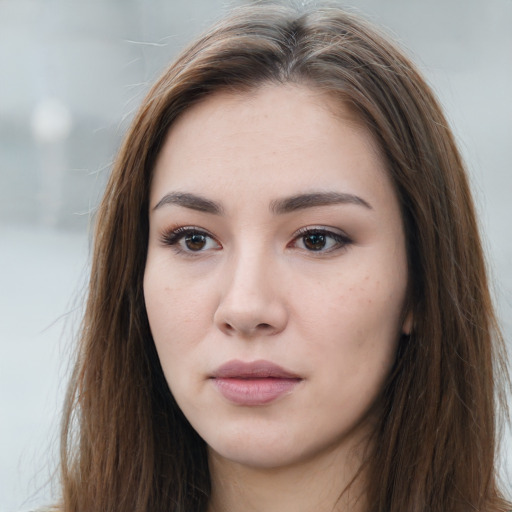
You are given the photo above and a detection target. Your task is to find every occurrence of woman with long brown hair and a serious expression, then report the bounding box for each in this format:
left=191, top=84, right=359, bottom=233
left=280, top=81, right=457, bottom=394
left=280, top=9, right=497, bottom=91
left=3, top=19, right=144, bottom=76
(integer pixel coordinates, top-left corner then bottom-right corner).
left=56, top=1, right=511, bottom=512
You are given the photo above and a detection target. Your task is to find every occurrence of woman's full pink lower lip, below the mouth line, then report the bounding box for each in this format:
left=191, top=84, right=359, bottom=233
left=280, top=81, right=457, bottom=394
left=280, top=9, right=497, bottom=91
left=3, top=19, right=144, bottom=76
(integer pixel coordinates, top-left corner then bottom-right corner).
left=213, top=377, right=301, bottom=406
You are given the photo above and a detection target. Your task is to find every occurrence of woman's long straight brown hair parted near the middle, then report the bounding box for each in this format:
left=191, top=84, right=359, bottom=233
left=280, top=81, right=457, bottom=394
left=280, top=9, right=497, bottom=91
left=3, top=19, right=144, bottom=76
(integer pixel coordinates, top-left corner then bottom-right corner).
left=61, top=5, right=512, bottom=512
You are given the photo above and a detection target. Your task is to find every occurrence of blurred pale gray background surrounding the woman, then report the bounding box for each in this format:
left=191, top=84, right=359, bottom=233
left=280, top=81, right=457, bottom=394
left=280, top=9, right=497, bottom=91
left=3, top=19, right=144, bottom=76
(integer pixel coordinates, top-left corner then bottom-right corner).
left=0, top=0, right=512, bottom=512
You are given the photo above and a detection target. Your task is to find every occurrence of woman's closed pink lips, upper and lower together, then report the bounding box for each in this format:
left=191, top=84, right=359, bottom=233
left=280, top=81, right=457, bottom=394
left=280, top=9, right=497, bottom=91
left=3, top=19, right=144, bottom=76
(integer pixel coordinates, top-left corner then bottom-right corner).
left=210, top=360, right=303, bottom=406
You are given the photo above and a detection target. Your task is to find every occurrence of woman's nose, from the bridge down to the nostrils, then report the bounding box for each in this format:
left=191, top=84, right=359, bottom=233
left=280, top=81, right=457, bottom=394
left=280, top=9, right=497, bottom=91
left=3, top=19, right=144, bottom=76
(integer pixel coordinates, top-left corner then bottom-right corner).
left=214, top=250, right=288, bottom=338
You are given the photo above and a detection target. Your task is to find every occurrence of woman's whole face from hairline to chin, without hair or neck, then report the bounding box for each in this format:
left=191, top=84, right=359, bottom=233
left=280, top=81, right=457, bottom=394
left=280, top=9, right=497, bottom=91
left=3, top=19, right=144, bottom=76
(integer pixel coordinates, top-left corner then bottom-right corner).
left=144, top=86, right=410, bottom=468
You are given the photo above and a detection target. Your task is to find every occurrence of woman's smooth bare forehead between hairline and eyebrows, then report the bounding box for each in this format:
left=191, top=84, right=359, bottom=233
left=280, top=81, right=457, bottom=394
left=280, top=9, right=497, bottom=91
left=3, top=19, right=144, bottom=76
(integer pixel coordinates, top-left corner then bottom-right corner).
left=151, top=85, right=391, bottom=210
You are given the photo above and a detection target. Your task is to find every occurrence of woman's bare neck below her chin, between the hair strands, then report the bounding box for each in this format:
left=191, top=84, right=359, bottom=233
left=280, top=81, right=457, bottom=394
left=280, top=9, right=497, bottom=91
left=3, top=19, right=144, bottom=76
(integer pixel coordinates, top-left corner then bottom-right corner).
left=208, top=440, right=365, bottom=512
